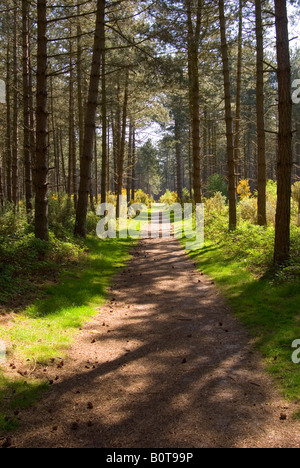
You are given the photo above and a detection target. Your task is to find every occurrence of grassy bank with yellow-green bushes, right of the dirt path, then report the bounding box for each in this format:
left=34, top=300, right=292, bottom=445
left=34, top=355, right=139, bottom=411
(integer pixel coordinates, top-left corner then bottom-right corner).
left=190, top=219, right=300, bottom=418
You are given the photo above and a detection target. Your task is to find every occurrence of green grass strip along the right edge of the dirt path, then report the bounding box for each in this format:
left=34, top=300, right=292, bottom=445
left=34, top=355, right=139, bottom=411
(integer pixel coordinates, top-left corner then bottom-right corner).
left=189, top=241, right=300, bottom=418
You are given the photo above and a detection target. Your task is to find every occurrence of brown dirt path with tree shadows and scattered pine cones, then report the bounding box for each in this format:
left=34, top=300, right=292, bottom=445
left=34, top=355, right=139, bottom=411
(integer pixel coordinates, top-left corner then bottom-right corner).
left=8, top=239, right=300, bottom=448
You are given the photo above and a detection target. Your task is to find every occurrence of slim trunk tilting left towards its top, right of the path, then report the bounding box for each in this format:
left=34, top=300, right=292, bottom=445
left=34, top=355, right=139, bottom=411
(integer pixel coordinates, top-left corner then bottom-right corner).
left=219, top=0, right=237, bottom=230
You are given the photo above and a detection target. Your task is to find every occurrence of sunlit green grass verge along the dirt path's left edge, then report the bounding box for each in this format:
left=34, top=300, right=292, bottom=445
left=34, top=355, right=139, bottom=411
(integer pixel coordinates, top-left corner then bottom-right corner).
left=0, top=238, right=133, bottom=432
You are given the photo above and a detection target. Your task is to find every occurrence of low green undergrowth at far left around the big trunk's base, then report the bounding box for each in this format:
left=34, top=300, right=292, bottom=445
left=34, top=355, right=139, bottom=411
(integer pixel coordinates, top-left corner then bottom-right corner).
left=0, top=198, right=85, bottom=305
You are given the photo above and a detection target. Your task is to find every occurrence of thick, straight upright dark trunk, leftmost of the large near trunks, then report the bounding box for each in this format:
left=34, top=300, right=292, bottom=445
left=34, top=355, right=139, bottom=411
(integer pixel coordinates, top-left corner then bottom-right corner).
left=35, top=0, right=49, bottom=241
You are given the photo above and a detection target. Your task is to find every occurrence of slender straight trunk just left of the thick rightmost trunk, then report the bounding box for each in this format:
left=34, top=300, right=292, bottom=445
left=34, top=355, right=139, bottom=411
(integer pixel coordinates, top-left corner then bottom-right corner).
left=255, top=0, right=267, bottom=226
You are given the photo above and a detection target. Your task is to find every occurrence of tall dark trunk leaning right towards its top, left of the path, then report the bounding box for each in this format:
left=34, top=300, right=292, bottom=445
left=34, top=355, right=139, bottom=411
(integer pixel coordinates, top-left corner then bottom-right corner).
left=75, top=0, right=105, bottom=237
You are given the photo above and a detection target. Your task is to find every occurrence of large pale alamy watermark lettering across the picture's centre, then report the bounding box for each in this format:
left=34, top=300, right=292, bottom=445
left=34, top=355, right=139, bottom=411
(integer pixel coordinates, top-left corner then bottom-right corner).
left=97, top=201, right=204, bottom=250
